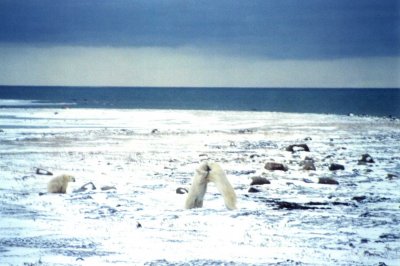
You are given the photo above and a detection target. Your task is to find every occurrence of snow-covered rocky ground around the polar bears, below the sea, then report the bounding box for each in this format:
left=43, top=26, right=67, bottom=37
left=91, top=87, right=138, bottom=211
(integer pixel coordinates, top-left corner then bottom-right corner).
left=0, top=108, right=400, bottom=265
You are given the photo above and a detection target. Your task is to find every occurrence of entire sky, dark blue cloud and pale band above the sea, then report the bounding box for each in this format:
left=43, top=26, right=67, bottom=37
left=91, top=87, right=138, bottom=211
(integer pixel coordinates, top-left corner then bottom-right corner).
left=0, top=0, right=400, bottom=88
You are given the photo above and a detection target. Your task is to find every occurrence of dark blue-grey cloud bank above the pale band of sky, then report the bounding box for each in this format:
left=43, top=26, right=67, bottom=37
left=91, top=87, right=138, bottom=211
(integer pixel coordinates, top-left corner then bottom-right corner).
left=0, top=0, right=400, bottom=59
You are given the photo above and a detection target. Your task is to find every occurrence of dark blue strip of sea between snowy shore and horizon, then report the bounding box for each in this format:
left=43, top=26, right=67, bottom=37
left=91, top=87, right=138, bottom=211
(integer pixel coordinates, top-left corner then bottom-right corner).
left=0, top=86, right=400, bottom=117
